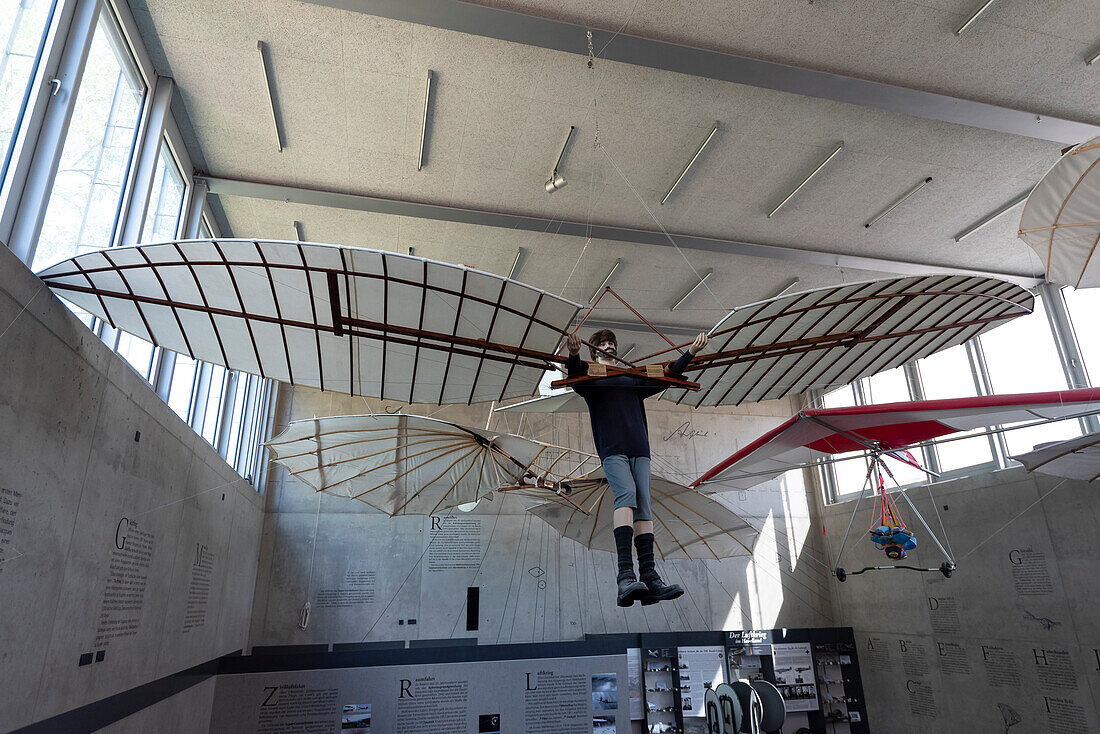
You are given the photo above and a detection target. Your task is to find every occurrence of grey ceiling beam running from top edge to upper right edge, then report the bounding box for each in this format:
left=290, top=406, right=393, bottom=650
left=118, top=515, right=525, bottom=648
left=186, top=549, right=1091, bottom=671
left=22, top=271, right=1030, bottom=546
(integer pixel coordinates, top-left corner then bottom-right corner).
left=306, top=0, right=1100, bottom=145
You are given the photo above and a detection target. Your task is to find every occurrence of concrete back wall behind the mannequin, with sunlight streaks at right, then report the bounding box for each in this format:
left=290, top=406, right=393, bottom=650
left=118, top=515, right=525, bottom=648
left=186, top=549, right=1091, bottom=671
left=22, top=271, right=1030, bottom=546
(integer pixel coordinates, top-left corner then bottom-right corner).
left=250, top=388, right=832, bottom=645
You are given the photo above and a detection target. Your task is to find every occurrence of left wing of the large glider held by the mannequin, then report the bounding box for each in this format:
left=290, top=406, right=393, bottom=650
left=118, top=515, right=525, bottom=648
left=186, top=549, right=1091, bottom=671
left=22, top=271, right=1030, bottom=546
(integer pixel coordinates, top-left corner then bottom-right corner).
left=40, top=240, right=580, bottom=404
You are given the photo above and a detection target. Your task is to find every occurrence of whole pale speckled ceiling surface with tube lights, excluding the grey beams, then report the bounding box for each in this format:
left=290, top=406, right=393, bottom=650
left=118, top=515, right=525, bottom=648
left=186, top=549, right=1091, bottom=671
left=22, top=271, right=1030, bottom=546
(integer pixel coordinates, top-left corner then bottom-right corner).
left=132, top=0, right=1082, bottom=341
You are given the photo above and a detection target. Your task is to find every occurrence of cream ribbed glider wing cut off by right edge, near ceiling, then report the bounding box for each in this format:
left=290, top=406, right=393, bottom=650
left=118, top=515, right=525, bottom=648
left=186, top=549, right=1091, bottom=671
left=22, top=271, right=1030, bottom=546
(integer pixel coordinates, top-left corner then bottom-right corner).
left=1018, top=138, right=1100, bottom=288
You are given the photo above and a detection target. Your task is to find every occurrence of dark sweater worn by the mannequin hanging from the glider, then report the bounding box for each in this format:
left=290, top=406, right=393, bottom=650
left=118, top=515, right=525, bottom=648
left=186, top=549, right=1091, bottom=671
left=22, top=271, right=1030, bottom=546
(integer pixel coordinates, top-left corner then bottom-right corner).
left=565, top=352, right=692, bottom=460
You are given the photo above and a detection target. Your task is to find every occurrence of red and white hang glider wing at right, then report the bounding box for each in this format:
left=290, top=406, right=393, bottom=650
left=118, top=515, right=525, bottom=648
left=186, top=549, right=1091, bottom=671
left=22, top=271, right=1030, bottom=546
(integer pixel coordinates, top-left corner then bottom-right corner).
left=693, top=387, right=1100, bottom=491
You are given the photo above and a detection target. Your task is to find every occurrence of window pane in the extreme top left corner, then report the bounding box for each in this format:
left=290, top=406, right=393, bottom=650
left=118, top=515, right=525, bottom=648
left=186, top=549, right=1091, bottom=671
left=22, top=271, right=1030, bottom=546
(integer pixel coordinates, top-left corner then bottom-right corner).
left=0, top=0, right=55, bottom=180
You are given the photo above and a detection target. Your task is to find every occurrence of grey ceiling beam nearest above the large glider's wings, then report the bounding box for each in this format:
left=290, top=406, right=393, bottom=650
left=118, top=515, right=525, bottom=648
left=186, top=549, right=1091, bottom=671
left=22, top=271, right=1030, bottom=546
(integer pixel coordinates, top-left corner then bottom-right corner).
left=204, top=174, right=1042, bottom=288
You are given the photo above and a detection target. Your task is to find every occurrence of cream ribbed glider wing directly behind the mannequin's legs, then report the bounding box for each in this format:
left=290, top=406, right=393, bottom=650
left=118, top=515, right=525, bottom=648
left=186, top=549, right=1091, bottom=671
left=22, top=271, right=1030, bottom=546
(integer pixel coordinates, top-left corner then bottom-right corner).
left=528, top=469, right=759, bottom=560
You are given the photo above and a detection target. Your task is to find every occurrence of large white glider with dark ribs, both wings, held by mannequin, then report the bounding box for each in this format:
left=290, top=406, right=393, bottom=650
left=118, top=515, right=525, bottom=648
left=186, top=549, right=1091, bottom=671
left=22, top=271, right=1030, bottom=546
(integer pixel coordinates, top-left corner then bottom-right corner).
left=41, top=240, right=1033, bottom=406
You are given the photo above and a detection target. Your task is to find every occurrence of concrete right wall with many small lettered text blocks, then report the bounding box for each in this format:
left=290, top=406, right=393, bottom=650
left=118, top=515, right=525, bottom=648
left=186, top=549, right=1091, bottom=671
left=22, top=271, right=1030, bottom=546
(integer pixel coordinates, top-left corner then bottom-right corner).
left=824, top=468, right=1100, bottom=734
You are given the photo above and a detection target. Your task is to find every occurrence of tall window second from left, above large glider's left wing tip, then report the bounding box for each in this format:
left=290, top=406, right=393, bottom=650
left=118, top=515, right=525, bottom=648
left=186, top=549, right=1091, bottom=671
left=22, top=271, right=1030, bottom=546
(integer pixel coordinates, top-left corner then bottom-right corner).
left=31, top=7, right=145, bottom=271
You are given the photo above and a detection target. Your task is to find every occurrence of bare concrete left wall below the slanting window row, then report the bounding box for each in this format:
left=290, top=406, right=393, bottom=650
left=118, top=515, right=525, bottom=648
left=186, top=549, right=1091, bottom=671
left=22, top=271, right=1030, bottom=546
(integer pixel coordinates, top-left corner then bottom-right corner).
left=0, top=248, right=263, bottom=730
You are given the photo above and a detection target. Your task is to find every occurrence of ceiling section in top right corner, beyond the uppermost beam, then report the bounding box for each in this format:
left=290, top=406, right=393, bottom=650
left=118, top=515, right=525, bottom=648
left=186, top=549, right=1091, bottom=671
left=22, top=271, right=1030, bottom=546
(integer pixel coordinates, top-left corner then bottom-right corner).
left=470, top=0, right=1100, bottom=124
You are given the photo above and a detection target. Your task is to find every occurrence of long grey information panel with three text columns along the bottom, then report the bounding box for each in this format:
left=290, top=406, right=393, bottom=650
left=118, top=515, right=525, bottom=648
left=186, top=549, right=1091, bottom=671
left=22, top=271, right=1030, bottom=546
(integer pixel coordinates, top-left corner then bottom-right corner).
left=210, top=655, right=630, bottom=734
